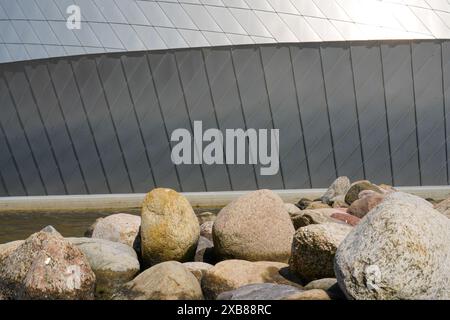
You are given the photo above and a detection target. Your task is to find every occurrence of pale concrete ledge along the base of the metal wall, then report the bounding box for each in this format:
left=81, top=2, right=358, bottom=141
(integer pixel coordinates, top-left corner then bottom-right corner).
left=0, top=186, right=450, bottom=213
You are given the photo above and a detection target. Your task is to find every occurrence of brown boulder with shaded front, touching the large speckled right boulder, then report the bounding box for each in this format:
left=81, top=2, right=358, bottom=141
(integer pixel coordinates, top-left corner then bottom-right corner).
left=289, top=223, right=352, bottom=282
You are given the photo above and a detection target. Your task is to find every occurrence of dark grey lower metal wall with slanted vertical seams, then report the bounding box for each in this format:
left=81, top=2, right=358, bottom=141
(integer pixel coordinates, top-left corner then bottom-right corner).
left=0, top=41, right=450, bottom=196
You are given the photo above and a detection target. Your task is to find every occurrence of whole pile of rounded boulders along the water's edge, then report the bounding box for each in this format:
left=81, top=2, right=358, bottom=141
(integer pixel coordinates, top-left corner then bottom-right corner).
left=0, top=177, right=450, bottom=300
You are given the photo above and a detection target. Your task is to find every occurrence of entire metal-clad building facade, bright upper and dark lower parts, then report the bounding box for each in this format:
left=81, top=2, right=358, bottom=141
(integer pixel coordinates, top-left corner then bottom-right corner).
left=0, top=0, right=450, bottom=196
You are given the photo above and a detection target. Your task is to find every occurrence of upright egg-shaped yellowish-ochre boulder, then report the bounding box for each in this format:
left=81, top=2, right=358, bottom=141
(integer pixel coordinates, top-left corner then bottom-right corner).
left=141, top=188, right=200, bottom=266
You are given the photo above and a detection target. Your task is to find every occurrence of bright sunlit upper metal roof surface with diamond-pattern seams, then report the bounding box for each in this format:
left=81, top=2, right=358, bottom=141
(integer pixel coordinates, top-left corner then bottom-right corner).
left=0, top=0, right=450, bottom=63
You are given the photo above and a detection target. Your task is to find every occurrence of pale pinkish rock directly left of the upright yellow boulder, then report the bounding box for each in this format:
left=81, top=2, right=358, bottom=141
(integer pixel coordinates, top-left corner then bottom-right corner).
left=91, top=213, right=141, bottom=250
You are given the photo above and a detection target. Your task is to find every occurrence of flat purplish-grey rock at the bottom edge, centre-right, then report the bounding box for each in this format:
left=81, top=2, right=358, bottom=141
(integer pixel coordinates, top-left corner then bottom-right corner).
left=217, top=283, right=301, bottom=300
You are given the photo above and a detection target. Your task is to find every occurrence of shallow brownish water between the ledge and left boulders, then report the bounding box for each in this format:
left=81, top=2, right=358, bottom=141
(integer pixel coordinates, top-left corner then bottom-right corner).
left=0, top=208, right=218, bottom=244
